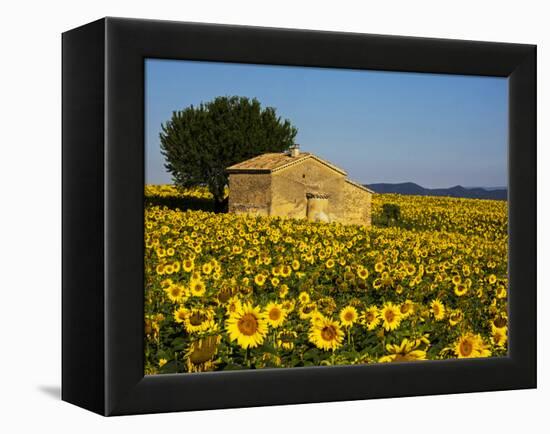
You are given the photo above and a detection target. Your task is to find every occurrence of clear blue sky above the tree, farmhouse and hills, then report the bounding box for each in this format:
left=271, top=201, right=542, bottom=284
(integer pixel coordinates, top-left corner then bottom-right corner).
left=145, top=59, right=508, bottom=187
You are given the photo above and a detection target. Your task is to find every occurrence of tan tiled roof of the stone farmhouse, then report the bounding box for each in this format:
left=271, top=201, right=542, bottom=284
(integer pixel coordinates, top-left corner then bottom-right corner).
left=227, top=152, right=346, bottom=175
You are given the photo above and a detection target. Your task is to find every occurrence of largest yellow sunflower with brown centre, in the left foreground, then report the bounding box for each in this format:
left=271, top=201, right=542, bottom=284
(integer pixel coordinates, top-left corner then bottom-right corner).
left=226, top=303, right=268, bottom=349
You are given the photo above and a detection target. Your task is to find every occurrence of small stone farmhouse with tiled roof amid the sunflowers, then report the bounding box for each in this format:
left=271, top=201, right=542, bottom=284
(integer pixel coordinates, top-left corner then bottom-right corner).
left=227, top=145, right=373, bottom=226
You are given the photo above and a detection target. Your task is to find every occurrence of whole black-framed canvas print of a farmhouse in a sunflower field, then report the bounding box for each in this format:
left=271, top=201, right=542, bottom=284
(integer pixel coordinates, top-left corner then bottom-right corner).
left=62, top=18, right=536, bottom=415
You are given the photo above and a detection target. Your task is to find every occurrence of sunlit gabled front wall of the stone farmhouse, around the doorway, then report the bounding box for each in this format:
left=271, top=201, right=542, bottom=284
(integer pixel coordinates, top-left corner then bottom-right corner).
left=271, top=159, right=345, bottom=221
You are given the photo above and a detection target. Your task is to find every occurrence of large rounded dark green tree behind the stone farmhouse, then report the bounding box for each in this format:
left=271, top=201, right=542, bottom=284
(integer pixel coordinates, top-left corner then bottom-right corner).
left=160, top=96, right=297, bottom=211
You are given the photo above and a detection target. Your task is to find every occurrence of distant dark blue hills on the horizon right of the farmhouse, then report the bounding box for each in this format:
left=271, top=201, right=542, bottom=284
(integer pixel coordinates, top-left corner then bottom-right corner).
left=366, top=182, right=508, bottom=200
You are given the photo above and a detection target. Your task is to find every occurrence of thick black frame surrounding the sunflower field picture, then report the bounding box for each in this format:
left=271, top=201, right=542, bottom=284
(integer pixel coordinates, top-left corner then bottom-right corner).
left=62, top=18, right=536, bottom=415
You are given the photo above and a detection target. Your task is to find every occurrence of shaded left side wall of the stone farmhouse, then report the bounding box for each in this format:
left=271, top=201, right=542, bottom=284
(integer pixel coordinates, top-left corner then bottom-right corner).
left=229, top=173, right=271, bottom=215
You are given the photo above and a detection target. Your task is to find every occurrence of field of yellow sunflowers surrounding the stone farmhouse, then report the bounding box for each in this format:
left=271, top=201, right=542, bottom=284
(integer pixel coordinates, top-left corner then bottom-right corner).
left=144, top=185, right=508, bottom=374
